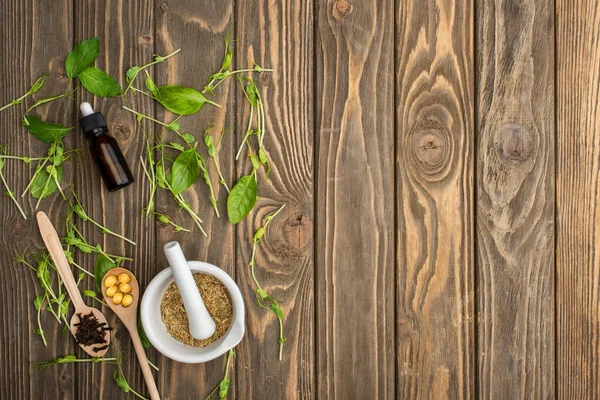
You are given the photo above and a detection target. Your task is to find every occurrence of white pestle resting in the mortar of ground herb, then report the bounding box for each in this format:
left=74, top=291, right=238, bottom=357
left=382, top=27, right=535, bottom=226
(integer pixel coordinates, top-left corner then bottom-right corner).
left=164, top=242, right=216, bottom=340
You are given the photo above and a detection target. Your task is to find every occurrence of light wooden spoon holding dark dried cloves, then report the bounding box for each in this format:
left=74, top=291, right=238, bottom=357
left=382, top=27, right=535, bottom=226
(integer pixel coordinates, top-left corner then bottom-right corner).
left=37, top=211, right=110, bottom=357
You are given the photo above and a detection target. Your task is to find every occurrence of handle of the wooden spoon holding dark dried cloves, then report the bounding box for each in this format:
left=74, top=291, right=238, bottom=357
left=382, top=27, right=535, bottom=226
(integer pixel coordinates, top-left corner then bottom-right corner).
left=37, top=211, right=85, bottom=309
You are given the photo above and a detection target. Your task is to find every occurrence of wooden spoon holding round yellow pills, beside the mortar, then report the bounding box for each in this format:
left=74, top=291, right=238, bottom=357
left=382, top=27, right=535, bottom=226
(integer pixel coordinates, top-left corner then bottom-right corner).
left=102, top=268, right=160, bottom=400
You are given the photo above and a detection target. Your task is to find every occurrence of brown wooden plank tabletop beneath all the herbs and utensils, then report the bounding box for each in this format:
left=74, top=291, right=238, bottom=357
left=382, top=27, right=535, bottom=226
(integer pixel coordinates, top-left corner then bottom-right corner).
left=0, top=0, right=600, bottom=400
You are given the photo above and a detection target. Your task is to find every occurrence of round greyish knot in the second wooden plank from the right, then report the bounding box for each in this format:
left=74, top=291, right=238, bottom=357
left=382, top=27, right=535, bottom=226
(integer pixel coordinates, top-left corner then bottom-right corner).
left=496, top=123, right=535, bottom=166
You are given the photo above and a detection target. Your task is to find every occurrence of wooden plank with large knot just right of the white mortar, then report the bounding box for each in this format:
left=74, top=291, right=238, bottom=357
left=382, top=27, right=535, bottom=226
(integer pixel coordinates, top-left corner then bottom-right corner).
left=235, top=0, right=315, bottom=399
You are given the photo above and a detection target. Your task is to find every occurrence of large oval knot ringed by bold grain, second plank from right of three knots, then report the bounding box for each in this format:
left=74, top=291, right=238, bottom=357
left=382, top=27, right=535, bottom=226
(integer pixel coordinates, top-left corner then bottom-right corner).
left=407, top=118, right=454, bottom=181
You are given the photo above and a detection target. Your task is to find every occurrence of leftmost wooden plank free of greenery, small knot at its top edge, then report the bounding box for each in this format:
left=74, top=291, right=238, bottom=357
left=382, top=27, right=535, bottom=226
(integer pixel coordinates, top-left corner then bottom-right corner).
left=314, top=0, right=395, bottom=399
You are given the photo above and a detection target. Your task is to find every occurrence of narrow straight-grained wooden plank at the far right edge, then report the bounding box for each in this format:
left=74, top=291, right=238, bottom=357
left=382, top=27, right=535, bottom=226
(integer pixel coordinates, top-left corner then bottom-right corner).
left=556, top=0, right=600, bottom=399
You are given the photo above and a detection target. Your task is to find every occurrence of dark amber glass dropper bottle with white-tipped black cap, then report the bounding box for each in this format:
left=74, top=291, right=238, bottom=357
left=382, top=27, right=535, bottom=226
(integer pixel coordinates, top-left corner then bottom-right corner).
left=79, top=103, right=133, bottom=192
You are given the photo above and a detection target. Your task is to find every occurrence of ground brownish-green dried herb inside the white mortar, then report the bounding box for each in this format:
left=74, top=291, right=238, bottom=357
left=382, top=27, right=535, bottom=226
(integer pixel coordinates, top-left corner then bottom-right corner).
left=160, top=274, right=233, bottom=347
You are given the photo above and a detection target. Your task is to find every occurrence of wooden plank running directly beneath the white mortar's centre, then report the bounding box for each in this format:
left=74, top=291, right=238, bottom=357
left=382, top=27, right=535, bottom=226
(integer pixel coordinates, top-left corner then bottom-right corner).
left=155, top=0, right=238, bottom=399
